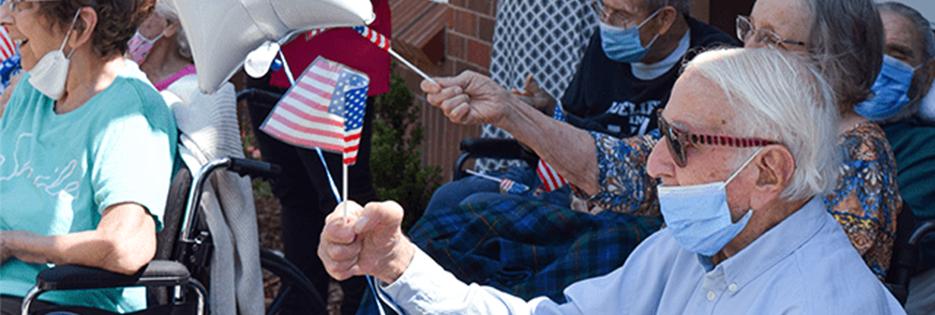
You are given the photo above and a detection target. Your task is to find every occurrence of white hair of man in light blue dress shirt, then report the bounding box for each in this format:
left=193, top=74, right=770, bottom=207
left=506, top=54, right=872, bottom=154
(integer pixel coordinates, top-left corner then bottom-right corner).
left=686, top=48, right=840, bottom=201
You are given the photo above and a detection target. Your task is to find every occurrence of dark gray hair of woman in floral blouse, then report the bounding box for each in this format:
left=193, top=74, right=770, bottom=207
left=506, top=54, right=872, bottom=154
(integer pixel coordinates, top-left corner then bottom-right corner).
left=806, top=0, right=884, bottom=113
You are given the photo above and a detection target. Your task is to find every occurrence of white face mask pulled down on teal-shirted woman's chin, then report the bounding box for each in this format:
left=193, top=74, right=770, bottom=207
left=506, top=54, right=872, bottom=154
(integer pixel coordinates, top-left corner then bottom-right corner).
left=29, top=11, right=81, bottom=100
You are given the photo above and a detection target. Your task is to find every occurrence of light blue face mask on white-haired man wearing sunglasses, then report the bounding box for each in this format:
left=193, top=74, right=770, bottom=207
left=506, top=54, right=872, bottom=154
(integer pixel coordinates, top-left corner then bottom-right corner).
left=657, top=148, right=762, bottom=257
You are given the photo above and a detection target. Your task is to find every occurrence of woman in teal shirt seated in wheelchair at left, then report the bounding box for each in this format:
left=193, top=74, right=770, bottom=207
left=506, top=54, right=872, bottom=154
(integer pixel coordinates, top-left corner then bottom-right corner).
left=0, top=0, right=177, bottom=314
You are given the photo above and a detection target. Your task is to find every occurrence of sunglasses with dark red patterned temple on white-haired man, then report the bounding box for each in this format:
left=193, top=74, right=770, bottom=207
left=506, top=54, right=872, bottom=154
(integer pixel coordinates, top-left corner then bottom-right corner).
left=656, top=110, right=780, bottom=167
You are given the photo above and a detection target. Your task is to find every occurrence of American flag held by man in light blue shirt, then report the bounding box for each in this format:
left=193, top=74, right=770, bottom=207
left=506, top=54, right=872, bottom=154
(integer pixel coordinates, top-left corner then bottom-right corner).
left=260, top=57, right=370, bottom=165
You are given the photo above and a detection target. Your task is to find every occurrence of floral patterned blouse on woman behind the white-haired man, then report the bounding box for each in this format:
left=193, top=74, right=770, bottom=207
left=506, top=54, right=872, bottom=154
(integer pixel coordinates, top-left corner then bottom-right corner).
left=572, top=122, right=902, bottom=279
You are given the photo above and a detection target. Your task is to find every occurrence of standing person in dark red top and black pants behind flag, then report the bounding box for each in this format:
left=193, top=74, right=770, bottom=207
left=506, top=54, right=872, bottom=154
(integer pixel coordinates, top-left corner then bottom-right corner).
left=247, top=0, right=391, bottom=314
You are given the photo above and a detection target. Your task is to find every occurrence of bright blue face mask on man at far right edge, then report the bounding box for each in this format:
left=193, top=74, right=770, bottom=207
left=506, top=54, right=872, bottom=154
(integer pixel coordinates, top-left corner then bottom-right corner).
left=854, top=56, right=915, bottom=120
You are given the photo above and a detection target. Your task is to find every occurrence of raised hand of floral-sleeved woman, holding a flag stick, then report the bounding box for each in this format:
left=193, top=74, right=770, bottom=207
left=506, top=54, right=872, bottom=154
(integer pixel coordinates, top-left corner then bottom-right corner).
left=421, top=71, right=517, bottom=126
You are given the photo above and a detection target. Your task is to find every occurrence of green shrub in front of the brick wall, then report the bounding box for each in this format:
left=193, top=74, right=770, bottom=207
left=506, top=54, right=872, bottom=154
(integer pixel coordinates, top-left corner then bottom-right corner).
left=370, top=73, right=441, bottom=230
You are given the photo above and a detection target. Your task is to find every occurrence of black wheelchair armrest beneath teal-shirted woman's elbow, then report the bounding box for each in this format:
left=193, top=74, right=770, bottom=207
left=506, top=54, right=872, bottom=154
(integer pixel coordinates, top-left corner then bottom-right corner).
left=36, top=260, right=191, bottom=291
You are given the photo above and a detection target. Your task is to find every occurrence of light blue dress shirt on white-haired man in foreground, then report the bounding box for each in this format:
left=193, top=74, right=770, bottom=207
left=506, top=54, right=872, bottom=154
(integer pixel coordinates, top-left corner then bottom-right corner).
left=382, top=199, right=905, bottom=315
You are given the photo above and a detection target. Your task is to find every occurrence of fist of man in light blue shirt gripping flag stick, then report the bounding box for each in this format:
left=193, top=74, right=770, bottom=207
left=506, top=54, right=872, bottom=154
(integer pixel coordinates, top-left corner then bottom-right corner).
left=318, top=201, right=415, bottom=283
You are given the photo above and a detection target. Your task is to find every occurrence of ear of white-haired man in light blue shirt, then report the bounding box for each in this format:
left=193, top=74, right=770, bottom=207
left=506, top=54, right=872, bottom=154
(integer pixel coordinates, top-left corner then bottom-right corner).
left=754, top=145, right=795, bottom=194
